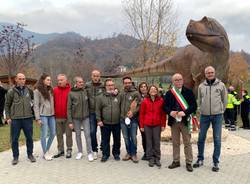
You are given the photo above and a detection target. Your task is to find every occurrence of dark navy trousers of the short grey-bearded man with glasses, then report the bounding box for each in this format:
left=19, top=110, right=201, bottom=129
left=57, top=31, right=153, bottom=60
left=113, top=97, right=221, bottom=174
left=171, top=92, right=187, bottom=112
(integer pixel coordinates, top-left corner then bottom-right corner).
left=101, top=123, right=121, bottom=158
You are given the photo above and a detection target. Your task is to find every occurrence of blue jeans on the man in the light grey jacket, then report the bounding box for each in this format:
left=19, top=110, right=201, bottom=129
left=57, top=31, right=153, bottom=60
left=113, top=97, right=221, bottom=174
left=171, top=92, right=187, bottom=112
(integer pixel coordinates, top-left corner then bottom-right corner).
left=198, top=114, right=223, bottom=164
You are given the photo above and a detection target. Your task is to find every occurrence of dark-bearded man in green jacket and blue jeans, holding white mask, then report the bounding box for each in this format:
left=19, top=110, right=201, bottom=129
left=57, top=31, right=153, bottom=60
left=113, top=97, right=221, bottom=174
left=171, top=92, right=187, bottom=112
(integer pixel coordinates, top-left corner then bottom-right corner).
left=120, top=76, right=140, bottom=163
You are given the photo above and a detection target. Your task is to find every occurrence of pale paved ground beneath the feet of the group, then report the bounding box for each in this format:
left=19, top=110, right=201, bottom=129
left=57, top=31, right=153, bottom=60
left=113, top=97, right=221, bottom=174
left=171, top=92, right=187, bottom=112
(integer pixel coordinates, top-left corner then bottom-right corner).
left=0, top=129, right=250, bottom=184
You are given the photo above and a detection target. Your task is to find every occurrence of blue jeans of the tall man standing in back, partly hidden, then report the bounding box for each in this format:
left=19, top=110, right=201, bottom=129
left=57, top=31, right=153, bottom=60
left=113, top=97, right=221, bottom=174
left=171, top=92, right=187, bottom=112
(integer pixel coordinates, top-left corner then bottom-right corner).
left=89, top=113, right=98, bottom=152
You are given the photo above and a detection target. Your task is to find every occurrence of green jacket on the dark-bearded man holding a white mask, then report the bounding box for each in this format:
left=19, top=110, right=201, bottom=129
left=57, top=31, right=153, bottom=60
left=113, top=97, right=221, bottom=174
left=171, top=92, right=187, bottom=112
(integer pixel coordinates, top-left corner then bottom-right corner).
left=121, top=88, right=141, bottom=119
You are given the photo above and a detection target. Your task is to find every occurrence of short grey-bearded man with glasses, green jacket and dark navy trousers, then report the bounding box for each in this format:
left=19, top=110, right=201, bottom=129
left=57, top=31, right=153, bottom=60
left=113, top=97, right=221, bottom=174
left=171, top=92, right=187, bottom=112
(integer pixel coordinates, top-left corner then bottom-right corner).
left=96, top=79, right=121, bottom=162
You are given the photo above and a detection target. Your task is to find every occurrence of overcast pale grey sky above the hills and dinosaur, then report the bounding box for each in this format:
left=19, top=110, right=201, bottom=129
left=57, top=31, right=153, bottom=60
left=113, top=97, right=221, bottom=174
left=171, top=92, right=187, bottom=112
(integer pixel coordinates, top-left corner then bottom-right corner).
left=0, top=0, right=250, bottom=53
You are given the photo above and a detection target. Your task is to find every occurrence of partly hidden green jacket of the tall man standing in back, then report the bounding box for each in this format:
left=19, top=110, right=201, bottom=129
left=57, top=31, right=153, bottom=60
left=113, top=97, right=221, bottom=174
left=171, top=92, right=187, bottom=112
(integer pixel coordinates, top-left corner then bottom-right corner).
left=85, top=81, right=105, bottom=113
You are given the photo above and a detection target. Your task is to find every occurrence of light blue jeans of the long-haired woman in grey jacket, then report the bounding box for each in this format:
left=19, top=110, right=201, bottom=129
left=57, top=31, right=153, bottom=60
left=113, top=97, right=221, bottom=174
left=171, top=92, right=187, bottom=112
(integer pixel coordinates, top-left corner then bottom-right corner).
left=40, top=116, right=56, bottom=154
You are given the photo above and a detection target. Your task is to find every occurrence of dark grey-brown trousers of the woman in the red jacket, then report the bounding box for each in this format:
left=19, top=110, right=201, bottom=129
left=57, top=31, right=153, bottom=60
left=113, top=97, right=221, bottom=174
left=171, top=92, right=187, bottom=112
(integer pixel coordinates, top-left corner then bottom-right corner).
left=144, top=125, right=161, bottom=160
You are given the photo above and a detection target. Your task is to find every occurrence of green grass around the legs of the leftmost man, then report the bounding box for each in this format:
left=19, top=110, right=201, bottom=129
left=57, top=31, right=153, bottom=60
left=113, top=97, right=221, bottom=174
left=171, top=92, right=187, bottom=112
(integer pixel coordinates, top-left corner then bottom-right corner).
left=0, top=122, right=40, bottom=152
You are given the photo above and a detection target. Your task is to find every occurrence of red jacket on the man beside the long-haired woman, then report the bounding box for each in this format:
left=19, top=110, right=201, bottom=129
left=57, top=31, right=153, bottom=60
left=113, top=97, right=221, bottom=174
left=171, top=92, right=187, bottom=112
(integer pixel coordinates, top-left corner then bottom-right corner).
left=54, top=83, right=70, bottom=119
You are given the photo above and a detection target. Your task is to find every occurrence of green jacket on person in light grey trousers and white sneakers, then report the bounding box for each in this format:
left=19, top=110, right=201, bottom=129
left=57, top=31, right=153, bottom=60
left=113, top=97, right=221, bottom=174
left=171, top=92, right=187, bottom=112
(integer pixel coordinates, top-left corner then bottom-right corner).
left=67, top=88, right=89, bottom=123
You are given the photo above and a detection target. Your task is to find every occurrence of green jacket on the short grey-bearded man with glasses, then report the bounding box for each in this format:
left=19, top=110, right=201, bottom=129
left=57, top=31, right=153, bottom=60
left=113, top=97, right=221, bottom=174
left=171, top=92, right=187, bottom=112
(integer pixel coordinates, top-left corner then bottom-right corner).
left=96, top=92, right=121, bottom=124
